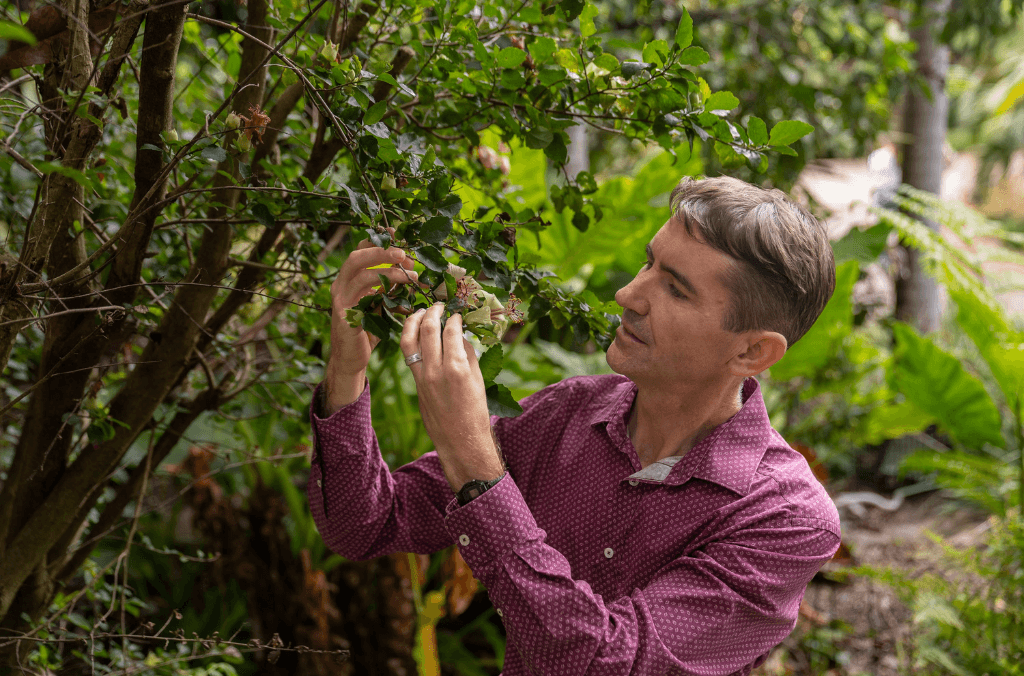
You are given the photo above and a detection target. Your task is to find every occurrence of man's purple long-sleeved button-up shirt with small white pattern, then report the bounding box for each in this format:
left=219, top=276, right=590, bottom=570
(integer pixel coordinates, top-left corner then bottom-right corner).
left=307, top=374, right=840, bottom=676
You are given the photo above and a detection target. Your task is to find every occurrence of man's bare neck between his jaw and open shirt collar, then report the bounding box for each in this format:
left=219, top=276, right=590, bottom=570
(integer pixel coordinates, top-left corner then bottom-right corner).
left=628, top=382, right=742, bottom=467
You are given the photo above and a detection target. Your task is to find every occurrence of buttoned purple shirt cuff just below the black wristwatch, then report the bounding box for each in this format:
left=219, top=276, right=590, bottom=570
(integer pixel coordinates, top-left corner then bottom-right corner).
left=444, top=472, right=548, bottom=586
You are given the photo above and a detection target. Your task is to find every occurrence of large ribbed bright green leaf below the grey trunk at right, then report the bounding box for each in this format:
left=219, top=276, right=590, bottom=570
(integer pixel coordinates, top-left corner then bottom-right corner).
left=893, top=322, right=1006, bottom=449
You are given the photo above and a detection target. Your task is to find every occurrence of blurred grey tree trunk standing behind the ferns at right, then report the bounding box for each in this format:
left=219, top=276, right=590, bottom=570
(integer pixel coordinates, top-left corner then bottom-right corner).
left=896, top=0, right=950, bottom=333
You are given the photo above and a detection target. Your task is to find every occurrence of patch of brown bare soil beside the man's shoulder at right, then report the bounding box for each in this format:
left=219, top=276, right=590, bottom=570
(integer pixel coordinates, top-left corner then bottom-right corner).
left=755, top=492, right=989, bottom=676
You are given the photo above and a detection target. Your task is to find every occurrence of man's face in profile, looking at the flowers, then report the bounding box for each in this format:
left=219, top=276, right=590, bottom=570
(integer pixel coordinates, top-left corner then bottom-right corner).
left=606, top=218, right=743, bottom=391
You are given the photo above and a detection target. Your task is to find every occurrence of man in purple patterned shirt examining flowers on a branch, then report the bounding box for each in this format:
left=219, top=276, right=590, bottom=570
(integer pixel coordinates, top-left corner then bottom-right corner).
left=308, top=178, right=840, bottom=676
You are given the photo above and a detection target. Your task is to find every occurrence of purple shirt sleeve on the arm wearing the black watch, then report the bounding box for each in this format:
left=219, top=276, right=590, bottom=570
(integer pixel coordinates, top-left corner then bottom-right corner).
left=445, top=476, right=839, bottom=676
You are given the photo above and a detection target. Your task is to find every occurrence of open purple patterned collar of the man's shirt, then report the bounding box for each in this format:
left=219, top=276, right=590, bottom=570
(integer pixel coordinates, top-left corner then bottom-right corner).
left=590, top=377, right=772, bottom=496
